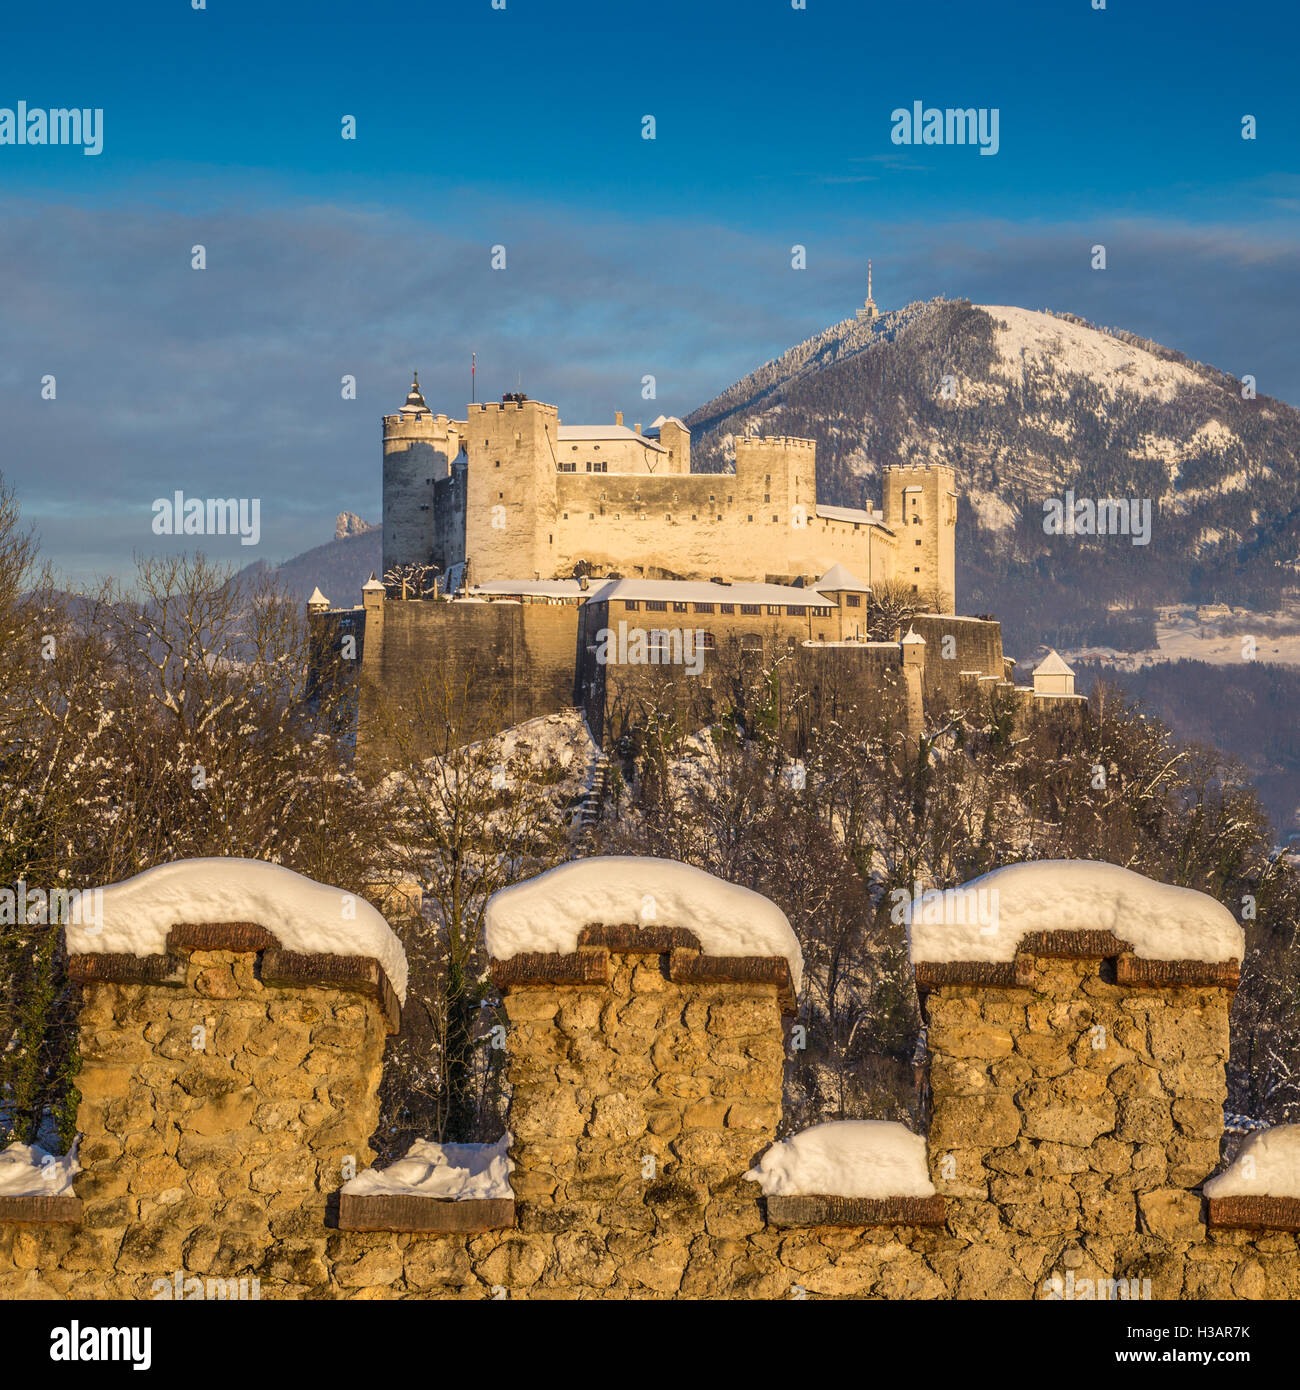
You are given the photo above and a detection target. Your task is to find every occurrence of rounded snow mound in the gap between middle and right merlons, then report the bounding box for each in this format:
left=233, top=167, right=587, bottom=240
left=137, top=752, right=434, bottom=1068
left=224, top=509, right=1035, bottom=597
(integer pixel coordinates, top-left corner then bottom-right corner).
left=745, top=1120, right=934, bottom=1198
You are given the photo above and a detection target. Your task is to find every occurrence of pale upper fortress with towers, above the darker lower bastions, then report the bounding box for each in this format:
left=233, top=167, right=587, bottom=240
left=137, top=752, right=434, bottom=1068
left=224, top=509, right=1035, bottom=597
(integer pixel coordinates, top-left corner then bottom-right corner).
left=384, top=379, right=957, bottom=613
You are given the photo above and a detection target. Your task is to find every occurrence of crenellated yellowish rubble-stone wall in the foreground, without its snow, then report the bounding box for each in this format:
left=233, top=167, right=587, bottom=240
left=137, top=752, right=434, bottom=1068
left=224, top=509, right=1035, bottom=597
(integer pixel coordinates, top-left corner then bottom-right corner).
left=0, top=889, right=1300, bottom=1298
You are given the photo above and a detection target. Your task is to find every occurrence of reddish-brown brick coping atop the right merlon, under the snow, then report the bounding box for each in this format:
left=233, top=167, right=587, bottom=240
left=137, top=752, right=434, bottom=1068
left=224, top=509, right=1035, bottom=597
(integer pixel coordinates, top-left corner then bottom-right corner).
left=913, top=931, right=1242, bottom=992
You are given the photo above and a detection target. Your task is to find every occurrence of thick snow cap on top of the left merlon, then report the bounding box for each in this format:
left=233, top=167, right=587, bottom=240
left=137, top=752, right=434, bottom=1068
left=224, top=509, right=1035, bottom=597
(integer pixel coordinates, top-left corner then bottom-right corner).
left=67, top=859, right=406, bottom=1002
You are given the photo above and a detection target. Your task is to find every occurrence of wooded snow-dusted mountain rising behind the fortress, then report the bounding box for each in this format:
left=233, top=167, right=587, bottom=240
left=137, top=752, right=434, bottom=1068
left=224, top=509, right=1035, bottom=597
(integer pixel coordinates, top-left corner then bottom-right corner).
left=688, top=300, right=1300, bottom=655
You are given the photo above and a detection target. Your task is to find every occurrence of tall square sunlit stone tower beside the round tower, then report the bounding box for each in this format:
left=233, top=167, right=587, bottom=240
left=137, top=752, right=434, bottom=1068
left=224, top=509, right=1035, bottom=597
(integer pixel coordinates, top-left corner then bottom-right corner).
left=466, top=392, right=560, bottom=584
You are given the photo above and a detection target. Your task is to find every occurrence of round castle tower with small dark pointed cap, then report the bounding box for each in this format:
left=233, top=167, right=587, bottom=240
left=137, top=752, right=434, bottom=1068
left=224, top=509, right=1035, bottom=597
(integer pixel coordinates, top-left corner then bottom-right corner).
left=382, top=374, right=460, bottom=574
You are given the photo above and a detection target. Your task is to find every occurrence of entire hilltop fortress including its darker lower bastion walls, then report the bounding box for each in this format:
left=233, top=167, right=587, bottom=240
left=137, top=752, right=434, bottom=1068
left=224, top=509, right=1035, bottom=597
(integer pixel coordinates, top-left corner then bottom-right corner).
left=309, top=381, right=1083, bottom=752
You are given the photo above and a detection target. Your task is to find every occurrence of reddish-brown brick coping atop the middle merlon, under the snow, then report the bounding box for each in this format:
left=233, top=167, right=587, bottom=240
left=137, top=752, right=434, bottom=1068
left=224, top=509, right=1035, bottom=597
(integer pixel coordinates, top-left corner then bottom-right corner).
left=492, top=923, right=795, bottom=1013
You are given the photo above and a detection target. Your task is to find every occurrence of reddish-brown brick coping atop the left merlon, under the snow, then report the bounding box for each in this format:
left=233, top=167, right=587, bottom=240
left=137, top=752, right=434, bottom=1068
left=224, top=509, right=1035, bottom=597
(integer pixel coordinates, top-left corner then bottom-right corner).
left=68, top=922, right=402, bottom=1033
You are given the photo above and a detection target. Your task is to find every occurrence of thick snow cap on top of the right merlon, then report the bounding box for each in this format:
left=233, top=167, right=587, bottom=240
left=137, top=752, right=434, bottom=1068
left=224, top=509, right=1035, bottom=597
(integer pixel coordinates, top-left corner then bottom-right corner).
left=905, top=859, right=1246, bottom=962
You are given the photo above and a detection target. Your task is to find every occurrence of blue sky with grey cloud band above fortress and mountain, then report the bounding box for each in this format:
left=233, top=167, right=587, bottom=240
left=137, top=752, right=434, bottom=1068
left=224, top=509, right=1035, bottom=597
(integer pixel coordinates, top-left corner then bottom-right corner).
left=0, top=0, right=1300, bottom=577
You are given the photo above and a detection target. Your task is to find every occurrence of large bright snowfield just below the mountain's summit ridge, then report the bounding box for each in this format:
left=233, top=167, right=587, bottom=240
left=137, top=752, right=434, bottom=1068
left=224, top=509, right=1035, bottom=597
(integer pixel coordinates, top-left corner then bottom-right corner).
left=977, top=304, right=1201, bottom=400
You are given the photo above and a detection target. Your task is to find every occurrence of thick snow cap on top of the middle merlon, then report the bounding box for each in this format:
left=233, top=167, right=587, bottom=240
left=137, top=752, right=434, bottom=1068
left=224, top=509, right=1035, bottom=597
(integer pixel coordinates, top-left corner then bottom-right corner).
left=485, top=855, right=804, bottom=990
